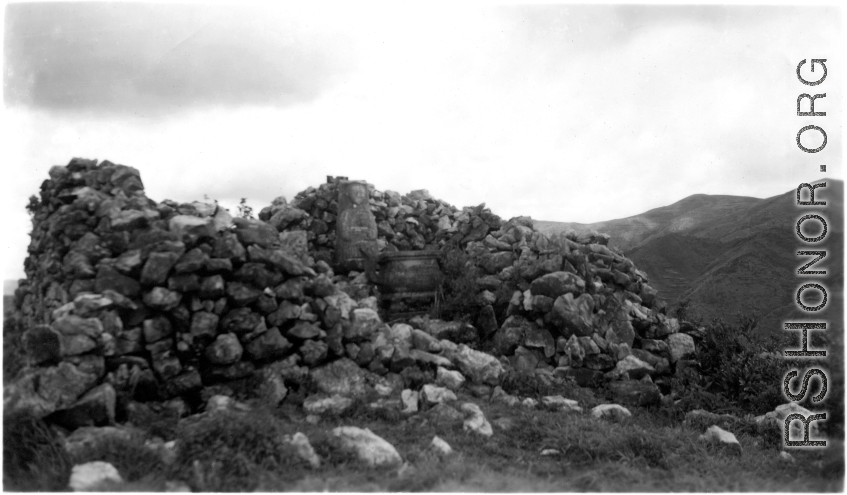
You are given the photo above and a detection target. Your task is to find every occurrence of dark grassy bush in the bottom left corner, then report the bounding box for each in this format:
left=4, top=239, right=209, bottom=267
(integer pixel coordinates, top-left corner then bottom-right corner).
left=3, top=416, right=72, bottom=492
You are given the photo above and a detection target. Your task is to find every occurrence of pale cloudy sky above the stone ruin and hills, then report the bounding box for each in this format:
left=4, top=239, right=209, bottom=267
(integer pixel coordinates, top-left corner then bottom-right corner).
left=2, top=2, right=845, bottom=278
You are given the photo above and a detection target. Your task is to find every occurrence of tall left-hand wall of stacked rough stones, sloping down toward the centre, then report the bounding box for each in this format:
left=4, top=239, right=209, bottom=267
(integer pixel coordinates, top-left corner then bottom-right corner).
left=4, top=159, right=516, bottom=426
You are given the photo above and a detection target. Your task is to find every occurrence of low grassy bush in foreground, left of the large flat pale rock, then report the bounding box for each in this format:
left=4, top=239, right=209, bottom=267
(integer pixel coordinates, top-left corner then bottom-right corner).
left=172, top=410, right=308, bottom=492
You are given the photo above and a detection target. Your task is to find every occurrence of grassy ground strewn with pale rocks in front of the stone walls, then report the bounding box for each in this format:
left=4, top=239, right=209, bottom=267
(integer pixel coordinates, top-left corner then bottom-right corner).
left=4, top=394, right=844, bottom=492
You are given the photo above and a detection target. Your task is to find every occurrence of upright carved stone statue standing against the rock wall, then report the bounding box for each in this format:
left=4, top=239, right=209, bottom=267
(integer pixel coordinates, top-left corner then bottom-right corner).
left=335, top=181, right=379, bottom=271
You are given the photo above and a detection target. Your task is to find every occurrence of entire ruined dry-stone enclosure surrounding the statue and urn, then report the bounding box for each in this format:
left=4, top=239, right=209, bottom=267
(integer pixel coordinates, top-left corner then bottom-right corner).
left=4, top=159, right=702, bottom=428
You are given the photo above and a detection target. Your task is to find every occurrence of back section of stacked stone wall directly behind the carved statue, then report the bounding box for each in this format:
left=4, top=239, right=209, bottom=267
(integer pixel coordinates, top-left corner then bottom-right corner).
left=259, top=178, right=503, bottom=263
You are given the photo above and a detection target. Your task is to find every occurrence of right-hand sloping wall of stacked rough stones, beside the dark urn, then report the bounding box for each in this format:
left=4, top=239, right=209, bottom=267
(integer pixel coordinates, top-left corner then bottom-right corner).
left=466, top=221, right=700, bottom=400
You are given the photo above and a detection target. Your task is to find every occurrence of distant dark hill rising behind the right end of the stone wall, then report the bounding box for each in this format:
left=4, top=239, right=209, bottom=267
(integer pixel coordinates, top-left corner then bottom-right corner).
left=536, top=179, right=844, bottom=332
